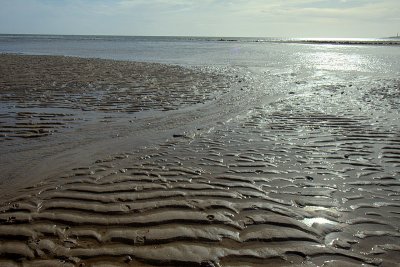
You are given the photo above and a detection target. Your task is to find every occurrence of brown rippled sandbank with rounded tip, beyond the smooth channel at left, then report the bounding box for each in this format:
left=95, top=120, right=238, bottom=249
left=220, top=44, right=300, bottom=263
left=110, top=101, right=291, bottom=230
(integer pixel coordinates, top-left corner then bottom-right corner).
left=0, top=54, right=229, bottom=141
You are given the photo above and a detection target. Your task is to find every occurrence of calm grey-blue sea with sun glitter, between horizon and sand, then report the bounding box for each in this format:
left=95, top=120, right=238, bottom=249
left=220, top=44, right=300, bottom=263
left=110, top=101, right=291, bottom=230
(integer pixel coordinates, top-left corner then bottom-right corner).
left=0, top=35, right=400, bottom=75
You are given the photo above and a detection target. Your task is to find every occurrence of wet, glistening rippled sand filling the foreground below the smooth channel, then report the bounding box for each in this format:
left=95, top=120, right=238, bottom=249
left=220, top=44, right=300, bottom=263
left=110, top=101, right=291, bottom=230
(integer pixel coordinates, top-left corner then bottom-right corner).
left=0, top=54, right=400, bottom=266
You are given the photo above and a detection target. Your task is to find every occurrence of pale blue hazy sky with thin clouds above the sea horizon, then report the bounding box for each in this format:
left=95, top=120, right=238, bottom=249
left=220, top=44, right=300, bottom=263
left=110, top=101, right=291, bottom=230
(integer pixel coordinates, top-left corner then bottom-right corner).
left=0, top=0, right=400, bottom=37
